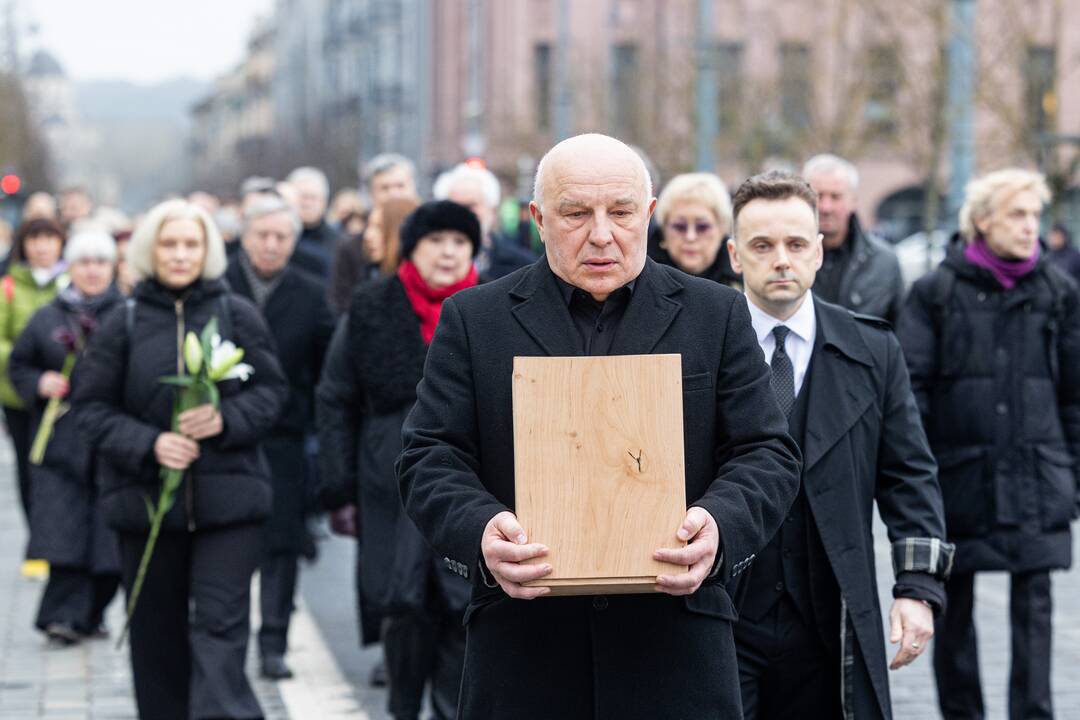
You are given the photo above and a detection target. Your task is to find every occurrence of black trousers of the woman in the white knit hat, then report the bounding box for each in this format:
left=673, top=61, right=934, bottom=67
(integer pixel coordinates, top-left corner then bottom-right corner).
left=35, top=565, right=120, bottom=634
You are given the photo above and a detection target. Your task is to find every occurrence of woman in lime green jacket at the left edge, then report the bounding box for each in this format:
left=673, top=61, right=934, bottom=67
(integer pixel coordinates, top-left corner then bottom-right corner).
left=0, top=213, right=67, bottom=557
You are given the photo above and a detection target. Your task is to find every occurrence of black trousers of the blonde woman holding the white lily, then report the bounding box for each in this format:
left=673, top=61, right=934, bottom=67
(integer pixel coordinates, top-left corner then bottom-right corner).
left=120, top=525, right=264, bottom=720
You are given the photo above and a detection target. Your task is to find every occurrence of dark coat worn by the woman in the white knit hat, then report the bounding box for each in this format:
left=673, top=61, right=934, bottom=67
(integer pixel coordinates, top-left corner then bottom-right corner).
left=8, top=289, right=121, bottom=573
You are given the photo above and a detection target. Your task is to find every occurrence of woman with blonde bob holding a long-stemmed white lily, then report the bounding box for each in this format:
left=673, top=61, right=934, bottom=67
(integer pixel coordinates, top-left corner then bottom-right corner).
left=73, top=200, right=288, bottom=720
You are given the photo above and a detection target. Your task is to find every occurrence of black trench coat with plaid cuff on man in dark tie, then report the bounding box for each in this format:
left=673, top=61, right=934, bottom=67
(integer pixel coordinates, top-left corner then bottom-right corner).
left=733, top=299, right=953, bottom=718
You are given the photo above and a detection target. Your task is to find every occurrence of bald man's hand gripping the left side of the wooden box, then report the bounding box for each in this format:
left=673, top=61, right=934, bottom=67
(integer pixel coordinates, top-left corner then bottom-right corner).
left=480, top=511, right=551, bottom=600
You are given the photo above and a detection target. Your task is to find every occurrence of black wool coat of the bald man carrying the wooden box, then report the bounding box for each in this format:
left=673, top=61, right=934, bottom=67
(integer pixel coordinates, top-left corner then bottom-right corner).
left=397, top=258, right=800, bottom=719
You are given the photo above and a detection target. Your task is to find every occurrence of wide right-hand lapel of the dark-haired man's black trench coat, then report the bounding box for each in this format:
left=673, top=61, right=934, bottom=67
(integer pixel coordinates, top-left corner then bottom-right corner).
left=802, top=298, right=876, bottom=476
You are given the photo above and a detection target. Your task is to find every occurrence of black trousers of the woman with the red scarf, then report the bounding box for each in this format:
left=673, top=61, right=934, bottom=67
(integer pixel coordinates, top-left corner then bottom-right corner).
left=382, top=611, right=465, bottom=720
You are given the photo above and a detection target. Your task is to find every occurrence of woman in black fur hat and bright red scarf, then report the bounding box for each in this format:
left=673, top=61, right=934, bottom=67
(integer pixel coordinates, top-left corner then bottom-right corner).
left=315, top=200, right=481, bottom=720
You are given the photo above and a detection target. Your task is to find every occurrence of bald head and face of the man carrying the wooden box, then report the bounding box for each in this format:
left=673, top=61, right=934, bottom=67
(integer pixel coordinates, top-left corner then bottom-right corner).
left=529, top=144, right=657, bottom=301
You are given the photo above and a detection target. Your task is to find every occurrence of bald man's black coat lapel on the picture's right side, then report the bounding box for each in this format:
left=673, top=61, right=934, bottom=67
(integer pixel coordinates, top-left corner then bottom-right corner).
left=611, top=259, right=683, bottom=355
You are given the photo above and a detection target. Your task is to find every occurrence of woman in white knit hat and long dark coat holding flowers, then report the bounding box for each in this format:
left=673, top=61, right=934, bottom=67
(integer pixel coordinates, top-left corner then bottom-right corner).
left=8, top=232, right=121, bottom=644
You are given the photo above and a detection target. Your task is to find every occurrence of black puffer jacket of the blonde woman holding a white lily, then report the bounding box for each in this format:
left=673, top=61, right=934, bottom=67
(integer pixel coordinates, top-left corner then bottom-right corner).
left=72, top=280, right=288, bottom=532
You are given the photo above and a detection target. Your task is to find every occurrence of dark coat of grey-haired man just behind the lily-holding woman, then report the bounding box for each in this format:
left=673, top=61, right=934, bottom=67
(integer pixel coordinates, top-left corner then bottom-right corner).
left=225, top=261, right=334, bottom=553
